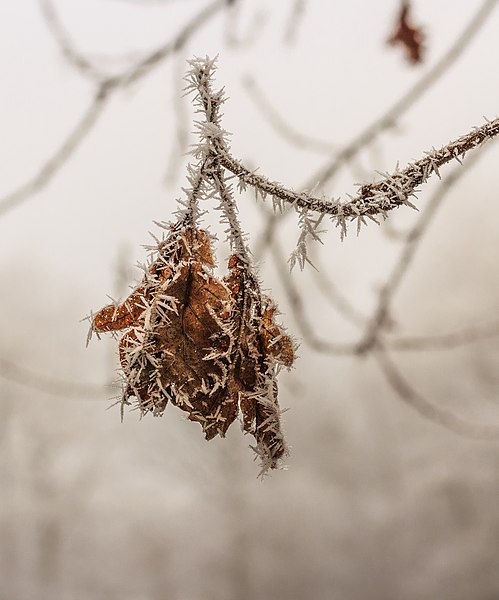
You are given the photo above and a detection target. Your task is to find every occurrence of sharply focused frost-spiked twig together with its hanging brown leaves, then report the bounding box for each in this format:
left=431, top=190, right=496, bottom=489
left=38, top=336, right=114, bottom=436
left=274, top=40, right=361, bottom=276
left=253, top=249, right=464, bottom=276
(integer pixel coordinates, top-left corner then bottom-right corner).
left=92, top=58, right=499, bottom=473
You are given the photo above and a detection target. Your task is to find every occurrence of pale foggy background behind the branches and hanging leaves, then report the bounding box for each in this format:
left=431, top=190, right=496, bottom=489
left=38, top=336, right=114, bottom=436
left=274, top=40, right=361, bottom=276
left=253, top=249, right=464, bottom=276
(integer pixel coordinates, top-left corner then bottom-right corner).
left=0, top=0, right=499, bottom=600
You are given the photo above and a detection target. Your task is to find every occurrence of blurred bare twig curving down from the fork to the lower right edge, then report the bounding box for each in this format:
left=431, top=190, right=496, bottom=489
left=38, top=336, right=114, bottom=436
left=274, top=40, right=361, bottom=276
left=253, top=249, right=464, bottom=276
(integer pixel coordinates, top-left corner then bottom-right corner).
left=374, top=345, right=499, bottom=440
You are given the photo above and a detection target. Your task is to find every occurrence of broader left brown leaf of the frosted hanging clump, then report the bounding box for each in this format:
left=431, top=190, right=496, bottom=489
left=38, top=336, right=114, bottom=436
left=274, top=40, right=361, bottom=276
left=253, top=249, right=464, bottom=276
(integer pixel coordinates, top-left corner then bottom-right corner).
left=93, top=228, right=232, bottom=426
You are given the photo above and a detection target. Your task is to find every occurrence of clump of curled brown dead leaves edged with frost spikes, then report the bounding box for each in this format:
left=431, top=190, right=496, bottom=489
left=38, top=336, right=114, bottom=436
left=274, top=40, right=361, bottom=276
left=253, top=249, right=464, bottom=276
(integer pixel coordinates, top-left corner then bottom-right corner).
left=93, top=221, right=294, bottom=473
